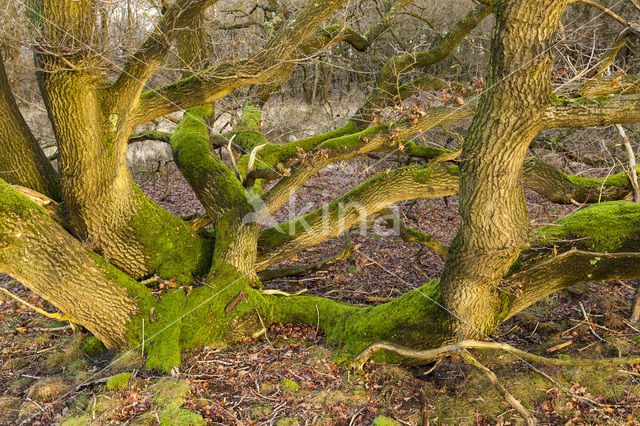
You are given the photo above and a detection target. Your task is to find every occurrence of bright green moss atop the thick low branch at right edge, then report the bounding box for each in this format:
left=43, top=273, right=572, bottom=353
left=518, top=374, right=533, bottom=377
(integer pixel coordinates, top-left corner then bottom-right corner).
left=534, top=201, right=640, bottom=252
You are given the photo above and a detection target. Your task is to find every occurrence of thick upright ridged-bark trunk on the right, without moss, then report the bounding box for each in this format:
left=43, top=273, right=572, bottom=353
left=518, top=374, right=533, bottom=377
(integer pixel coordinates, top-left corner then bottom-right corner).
left=441, top=0, right=566, bottom=337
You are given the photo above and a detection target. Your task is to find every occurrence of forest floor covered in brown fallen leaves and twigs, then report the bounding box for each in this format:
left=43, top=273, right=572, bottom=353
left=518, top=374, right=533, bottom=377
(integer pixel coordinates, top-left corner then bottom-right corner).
left=0, top=158, right=640, bottom=425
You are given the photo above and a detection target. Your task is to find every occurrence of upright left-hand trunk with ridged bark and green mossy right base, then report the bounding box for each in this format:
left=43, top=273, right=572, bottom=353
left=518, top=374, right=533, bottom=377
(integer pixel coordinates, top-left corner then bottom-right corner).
left=31, top=0, right=211, bottom=282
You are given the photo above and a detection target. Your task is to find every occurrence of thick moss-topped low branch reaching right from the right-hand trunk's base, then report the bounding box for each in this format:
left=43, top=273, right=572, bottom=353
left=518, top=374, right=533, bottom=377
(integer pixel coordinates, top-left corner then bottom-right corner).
left=501, top=201, right=640, bottom=316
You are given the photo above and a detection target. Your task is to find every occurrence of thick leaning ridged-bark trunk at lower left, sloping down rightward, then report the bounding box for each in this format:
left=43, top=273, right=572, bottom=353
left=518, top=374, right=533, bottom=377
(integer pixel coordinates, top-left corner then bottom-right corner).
left=0, top=180, right=150, bottom=348
